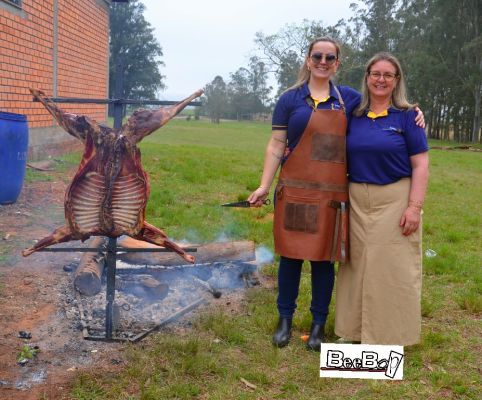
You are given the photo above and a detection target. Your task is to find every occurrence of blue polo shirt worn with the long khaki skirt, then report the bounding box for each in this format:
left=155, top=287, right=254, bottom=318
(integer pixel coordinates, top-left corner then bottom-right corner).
left=346, top=107, right=428, bottom=185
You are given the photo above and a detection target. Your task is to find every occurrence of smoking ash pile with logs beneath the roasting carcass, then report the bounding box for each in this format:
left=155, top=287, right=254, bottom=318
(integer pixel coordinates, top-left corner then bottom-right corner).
left=68, top=237, right=259, bottom=341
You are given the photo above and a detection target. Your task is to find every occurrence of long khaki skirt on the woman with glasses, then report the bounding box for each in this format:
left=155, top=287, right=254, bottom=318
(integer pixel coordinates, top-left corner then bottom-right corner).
left=335, top=178, right=422, bottom=346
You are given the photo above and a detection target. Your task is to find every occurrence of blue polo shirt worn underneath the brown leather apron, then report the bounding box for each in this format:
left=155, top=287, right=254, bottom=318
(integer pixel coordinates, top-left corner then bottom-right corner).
left=272, top=81, right=361, bottom=151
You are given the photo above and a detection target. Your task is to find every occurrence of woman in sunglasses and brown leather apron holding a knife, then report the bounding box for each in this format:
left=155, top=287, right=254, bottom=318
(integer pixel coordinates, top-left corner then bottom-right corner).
left=248, top=38, right=360, bottom=351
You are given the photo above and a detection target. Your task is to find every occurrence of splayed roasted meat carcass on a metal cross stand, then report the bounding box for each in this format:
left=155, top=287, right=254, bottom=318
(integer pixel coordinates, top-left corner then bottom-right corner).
left=22, top=89, right=203, bottom=262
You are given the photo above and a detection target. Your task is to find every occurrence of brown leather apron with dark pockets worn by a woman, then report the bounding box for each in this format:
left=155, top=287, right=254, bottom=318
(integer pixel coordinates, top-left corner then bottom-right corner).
left=273, top=86, right=348, bottom=262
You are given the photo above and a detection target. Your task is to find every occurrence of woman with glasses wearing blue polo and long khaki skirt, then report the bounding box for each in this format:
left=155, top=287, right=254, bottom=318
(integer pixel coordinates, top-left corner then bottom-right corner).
left=335, top=53, right=429, bottom=345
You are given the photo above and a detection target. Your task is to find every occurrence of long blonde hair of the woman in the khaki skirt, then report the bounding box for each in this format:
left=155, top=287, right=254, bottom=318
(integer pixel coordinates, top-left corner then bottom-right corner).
left=353, top=52, right=416, bottom=117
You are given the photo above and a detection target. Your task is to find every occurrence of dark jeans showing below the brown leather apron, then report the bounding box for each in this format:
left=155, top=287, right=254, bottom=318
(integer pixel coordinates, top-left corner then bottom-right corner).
left=277, top=257, right=335, bottom=324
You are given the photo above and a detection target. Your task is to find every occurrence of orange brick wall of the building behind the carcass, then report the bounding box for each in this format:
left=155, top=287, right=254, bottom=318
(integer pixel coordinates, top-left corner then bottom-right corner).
left=0, top=0, right=109, bottom=158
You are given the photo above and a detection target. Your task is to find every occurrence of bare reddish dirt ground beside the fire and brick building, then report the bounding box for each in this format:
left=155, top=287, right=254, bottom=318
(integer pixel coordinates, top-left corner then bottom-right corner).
left=0, top=166, right=270, bottom=400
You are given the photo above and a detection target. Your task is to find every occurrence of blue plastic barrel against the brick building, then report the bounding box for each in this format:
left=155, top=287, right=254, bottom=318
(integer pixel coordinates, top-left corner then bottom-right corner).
left=0, top=112, right=28, bottom=204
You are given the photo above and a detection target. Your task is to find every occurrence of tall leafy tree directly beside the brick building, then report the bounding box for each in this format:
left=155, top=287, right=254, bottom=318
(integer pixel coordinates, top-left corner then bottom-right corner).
left=109, top=0, right=164, bottom=99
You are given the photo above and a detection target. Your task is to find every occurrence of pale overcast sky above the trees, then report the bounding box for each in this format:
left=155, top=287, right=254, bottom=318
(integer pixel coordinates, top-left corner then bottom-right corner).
left=142, top=0, right=353, bottom=100
